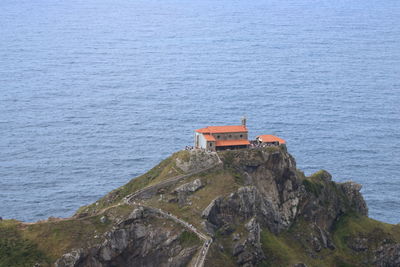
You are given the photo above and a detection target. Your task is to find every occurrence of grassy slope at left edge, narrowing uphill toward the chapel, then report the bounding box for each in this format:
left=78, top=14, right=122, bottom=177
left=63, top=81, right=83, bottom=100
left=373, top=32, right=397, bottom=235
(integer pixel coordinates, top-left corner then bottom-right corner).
left=0, top=151, right=191, bottom=267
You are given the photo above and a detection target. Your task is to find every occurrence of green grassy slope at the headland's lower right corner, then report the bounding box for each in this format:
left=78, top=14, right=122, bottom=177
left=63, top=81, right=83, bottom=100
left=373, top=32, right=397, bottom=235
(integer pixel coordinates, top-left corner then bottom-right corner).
left=261, top=214, right=400, bottom=266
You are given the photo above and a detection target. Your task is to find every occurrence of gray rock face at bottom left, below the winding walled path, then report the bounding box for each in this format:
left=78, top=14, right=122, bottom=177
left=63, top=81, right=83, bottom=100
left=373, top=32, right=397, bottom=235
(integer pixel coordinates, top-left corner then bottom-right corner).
left=55, top=208, right=199, bottom=267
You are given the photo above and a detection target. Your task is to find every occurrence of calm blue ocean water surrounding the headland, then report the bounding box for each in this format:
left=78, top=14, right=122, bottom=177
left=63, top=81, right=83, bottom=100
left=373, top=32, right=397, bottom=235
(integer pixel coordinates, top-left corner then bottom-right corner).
left=0, top=0, right=400, bottom=223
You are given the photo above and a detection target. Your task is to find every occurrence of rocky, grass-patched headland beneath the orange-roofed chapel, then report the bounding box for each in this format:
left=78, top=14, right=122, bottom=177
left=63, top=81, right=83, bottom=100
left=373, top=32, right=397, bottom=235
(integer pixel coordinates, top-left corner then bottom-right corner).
left=0, top=146, right=400, bottom=267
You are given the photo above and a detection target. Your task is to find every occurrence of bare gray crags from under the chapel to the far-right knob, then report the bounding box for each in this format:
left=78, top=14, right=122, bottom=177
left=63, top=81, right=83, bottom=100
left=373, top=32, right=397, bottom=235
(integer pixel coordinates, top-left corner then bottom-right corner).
left=202, top=150, right=376, bottom=266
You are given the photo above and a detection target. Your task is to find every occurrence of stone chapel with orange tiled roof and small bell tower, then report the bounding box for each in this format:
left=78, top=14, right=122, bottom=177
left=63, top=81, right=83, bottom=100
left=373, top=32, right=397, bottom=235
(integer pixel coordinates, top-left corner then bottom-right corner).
left=194, top=119, right=250, bottom=151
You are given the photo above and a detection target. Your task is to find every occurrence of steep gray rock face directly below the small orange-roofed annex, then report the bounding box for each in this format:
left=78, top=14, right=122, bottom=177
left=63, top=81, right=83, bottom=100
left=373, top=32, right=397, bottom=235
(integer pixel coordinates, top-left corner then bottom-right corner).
left=202, top=150, right=304, bottom=233
